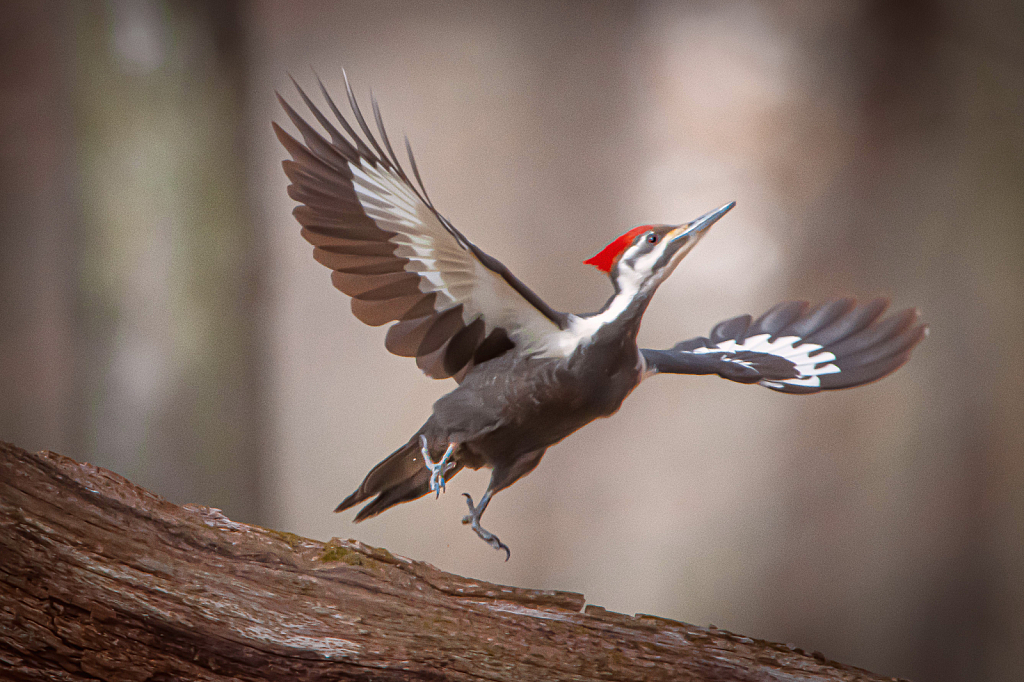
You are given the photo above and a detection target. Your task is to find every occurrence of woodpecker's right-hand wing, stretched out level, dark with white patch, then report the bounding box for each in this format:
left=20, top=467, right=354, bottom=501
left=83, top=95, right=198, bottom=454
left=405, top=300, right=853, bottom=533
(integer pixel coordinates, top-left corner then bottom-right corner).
left=641, top=298, right=928, bottom=393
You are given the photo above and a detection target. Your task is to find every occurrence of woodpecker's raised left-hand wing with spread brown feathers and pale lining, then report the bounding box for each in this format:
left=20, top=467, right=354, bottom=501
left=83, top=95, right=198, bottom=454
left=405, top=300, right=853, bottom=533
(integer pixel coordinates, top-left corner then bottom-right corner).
left=273, top=77, right=565, bottom=379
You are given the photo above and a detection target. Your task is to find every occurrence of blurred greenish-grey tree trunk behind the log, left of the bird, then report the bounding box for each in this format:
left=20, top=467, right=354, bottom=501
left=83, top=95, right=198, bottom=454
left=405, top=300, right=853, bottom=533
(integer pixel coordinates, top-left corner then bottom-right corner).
left=74, top=0, right=267, bottom=521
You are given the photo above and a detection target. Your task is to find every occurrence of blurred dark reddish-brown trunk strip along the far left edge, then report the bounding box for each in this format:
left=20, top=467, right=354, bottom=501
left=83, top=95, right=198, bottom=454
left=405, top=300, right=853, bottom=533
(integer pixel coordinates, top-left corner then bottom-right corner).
left=0, top=0, right=80, bottom=452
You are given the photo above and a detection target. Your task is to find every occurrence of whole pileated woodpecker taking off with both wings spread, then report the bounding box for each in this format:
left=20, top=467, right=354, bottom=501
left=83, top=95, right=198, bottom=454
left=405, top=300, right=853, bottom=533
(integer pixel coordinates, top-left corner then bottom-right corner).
left=273, top=76, right=927, bottom=560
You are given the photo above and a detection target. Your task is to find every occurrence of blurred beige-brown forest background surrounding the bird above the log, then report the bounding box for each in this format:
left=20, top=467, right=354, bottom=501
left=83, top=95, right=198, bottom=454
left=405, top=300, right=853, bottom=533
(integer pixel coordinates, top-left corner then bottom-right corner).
left=0, top=0, right=1024, bottom=681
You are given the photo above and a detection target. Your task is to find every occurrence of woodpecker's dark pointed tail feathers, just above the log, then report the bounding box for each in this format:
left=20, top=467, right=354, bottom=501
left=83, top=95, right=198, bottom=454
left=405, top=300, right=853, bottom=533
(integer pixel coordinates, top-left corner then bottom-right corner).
left=335, top=433, right=462, bottom=521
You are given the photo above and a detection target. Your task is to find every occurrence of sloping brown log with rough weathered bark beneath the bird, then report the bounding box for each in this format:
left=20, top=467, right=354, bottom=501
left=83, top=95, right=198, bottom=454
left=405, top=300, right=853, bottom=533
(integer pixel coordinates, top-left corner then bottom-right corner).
left=0, top=442, right=909, bottom=682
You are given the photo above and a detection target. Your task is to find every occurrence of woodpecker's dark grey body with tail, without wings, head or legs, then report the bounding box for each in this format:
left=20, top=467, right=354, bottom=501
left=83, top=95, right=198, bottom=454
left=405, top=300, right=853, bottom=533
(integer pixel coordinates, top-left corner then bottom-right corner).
left=338, top=319, right=643, bottom=520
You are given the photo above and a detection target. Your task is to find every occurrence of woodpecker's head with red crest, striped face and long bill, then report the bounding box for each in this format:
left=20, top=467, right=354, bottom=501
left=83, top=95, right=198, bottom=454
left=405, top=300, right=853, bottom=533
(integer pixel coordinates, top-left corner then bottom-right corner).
left=584, top=202, right=736, bottom=293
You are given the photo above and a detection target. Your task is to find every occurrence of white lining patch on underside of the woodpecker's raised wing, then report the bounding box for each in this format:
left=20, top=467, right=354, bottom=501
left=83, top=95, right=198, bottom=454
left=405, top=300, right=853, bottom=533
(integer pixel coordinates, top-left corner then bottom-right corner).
left=348, top=159, right=559, bottom=352
